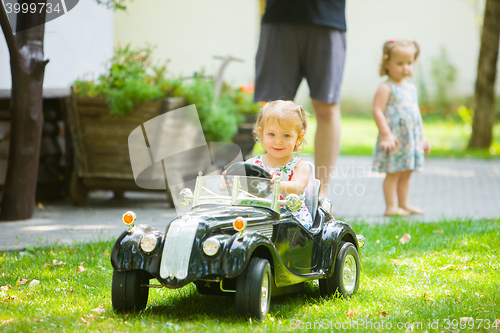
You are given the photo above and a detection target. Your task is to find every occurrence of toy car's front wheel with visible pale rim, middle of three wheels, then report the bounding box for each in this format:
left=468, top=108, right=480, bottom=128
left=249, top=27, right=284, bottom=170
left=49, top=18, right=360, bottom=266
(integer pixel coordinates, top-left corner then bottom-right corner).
left=235, top=258, right=272, bottom=320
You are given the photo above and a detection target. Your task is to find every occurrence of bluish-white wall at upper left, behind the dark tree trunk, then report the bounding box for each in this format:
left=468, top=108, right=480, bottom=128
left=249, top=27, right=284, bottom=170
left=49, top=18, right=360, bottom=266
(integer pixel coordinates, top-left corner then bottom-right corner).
left=0, top=0, right=113, bottom=89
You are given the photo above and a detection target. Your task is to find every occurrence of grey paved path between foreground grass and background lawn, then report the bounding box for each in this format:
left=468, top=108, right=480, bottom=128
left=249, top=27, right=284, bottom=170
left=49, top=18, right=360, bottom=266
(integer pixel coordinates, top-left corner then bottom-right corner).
left=0, top=156, right=500, bottom=251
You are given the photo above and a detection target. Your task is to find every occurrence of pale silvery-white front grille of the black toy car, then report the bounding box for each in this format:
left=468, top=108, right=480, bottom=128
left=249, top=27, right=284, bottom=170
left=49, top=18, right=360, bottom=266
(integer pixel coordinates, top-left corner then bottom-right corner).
left=160, top=219, right=198, bottom=280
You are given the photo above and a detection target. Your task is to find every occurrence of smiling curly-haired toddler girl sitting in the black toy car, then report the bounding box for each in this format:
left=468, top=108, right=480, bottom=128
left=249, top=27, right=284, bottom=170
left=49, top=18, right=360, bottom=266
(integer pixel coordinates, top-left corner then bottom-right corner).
left=247, top=100, right=312, bottom=228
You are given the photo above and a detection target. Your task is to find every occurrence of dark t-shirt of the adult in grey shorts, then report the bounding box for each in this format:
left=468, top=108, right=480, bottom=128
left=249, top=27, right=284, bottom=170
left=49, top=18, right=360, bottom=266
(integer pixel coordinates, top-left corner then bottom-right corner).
left=262, top=0, right=346, bottom=31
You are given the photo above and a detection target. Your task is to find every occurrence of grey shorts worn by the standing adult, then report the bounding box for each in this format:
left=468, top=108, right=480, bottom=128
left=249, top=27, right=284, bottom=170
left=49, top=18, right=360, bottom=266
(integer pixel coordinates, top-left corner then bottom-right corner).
left=254, top=23, right=346, bottom=103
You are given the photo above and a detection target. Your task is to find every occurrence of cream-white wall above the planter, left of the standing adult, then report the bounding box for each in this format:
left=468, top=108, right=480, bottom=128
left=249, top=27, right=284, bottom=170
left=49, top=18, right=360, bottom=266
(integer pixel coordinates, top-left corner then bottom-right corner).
left=115, top=0, right=260, bottom=85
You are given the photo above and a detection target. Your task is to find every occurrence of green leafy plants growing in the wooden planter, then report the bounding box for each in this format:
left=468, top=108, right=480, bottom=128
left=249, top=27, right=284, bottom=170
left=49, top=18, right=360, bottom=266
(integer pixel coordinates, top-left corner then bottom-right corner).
left=72, top=44, right=259, bottom=142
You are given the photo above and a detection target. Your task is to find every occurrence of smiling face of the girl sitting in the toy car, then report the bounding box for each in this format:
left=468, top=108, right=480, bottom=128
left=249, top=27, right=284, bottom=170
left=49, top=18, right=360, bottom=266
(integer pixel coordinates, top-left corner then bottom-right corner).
left=259, top=118, right=304, bottom=159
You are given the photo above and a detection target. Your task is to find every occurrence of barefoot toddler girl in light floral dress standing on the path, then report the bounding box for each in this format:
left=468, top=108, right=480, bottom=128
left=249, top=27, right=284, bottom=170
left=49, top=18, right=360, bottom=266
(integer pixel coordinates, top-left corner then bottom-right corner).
left=373, top=40, right=431, bottom=216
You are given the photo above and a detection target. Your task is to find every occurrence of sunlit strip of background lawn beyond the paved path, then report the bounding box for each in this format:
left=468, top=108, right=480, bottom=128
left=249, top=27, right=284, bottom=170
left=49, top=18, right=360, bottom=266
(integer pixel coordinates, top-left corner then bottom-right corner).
left=255, top=116, right=500, bottom=159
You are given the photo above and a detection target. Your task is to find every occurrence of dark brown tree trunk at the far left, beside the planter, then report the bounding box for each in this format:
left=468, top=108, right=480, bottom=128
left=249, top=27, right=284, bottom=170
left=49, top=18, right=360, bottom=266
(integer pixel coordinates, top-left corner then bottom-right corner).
left=0, top=0, right=48, bottom=220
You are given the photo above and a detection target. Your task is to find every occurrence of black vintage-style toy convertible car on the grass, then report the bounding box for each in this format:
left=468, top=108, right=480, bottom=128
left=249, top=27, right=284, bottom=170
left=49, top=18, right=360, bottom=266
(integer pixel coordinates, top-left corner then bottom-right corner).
left=111, top=163, right=365, bottom=319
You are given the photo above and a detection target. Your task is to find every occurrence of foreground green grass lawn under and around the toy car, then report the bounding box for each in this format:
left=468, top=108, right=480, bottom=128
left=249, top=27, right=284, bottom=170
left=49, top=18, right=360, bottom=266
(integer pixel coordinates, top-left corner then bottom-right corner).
left=0, top=219, right=500, bottom=332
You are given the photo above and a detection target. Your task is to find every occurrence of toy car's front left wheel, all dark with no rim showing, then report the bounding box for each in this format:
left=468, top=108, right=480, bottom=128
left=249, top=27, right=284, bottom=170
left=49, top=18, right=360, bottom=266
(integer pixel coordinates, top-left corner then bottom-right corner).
left=111, top=270, right=149, bottom=312
